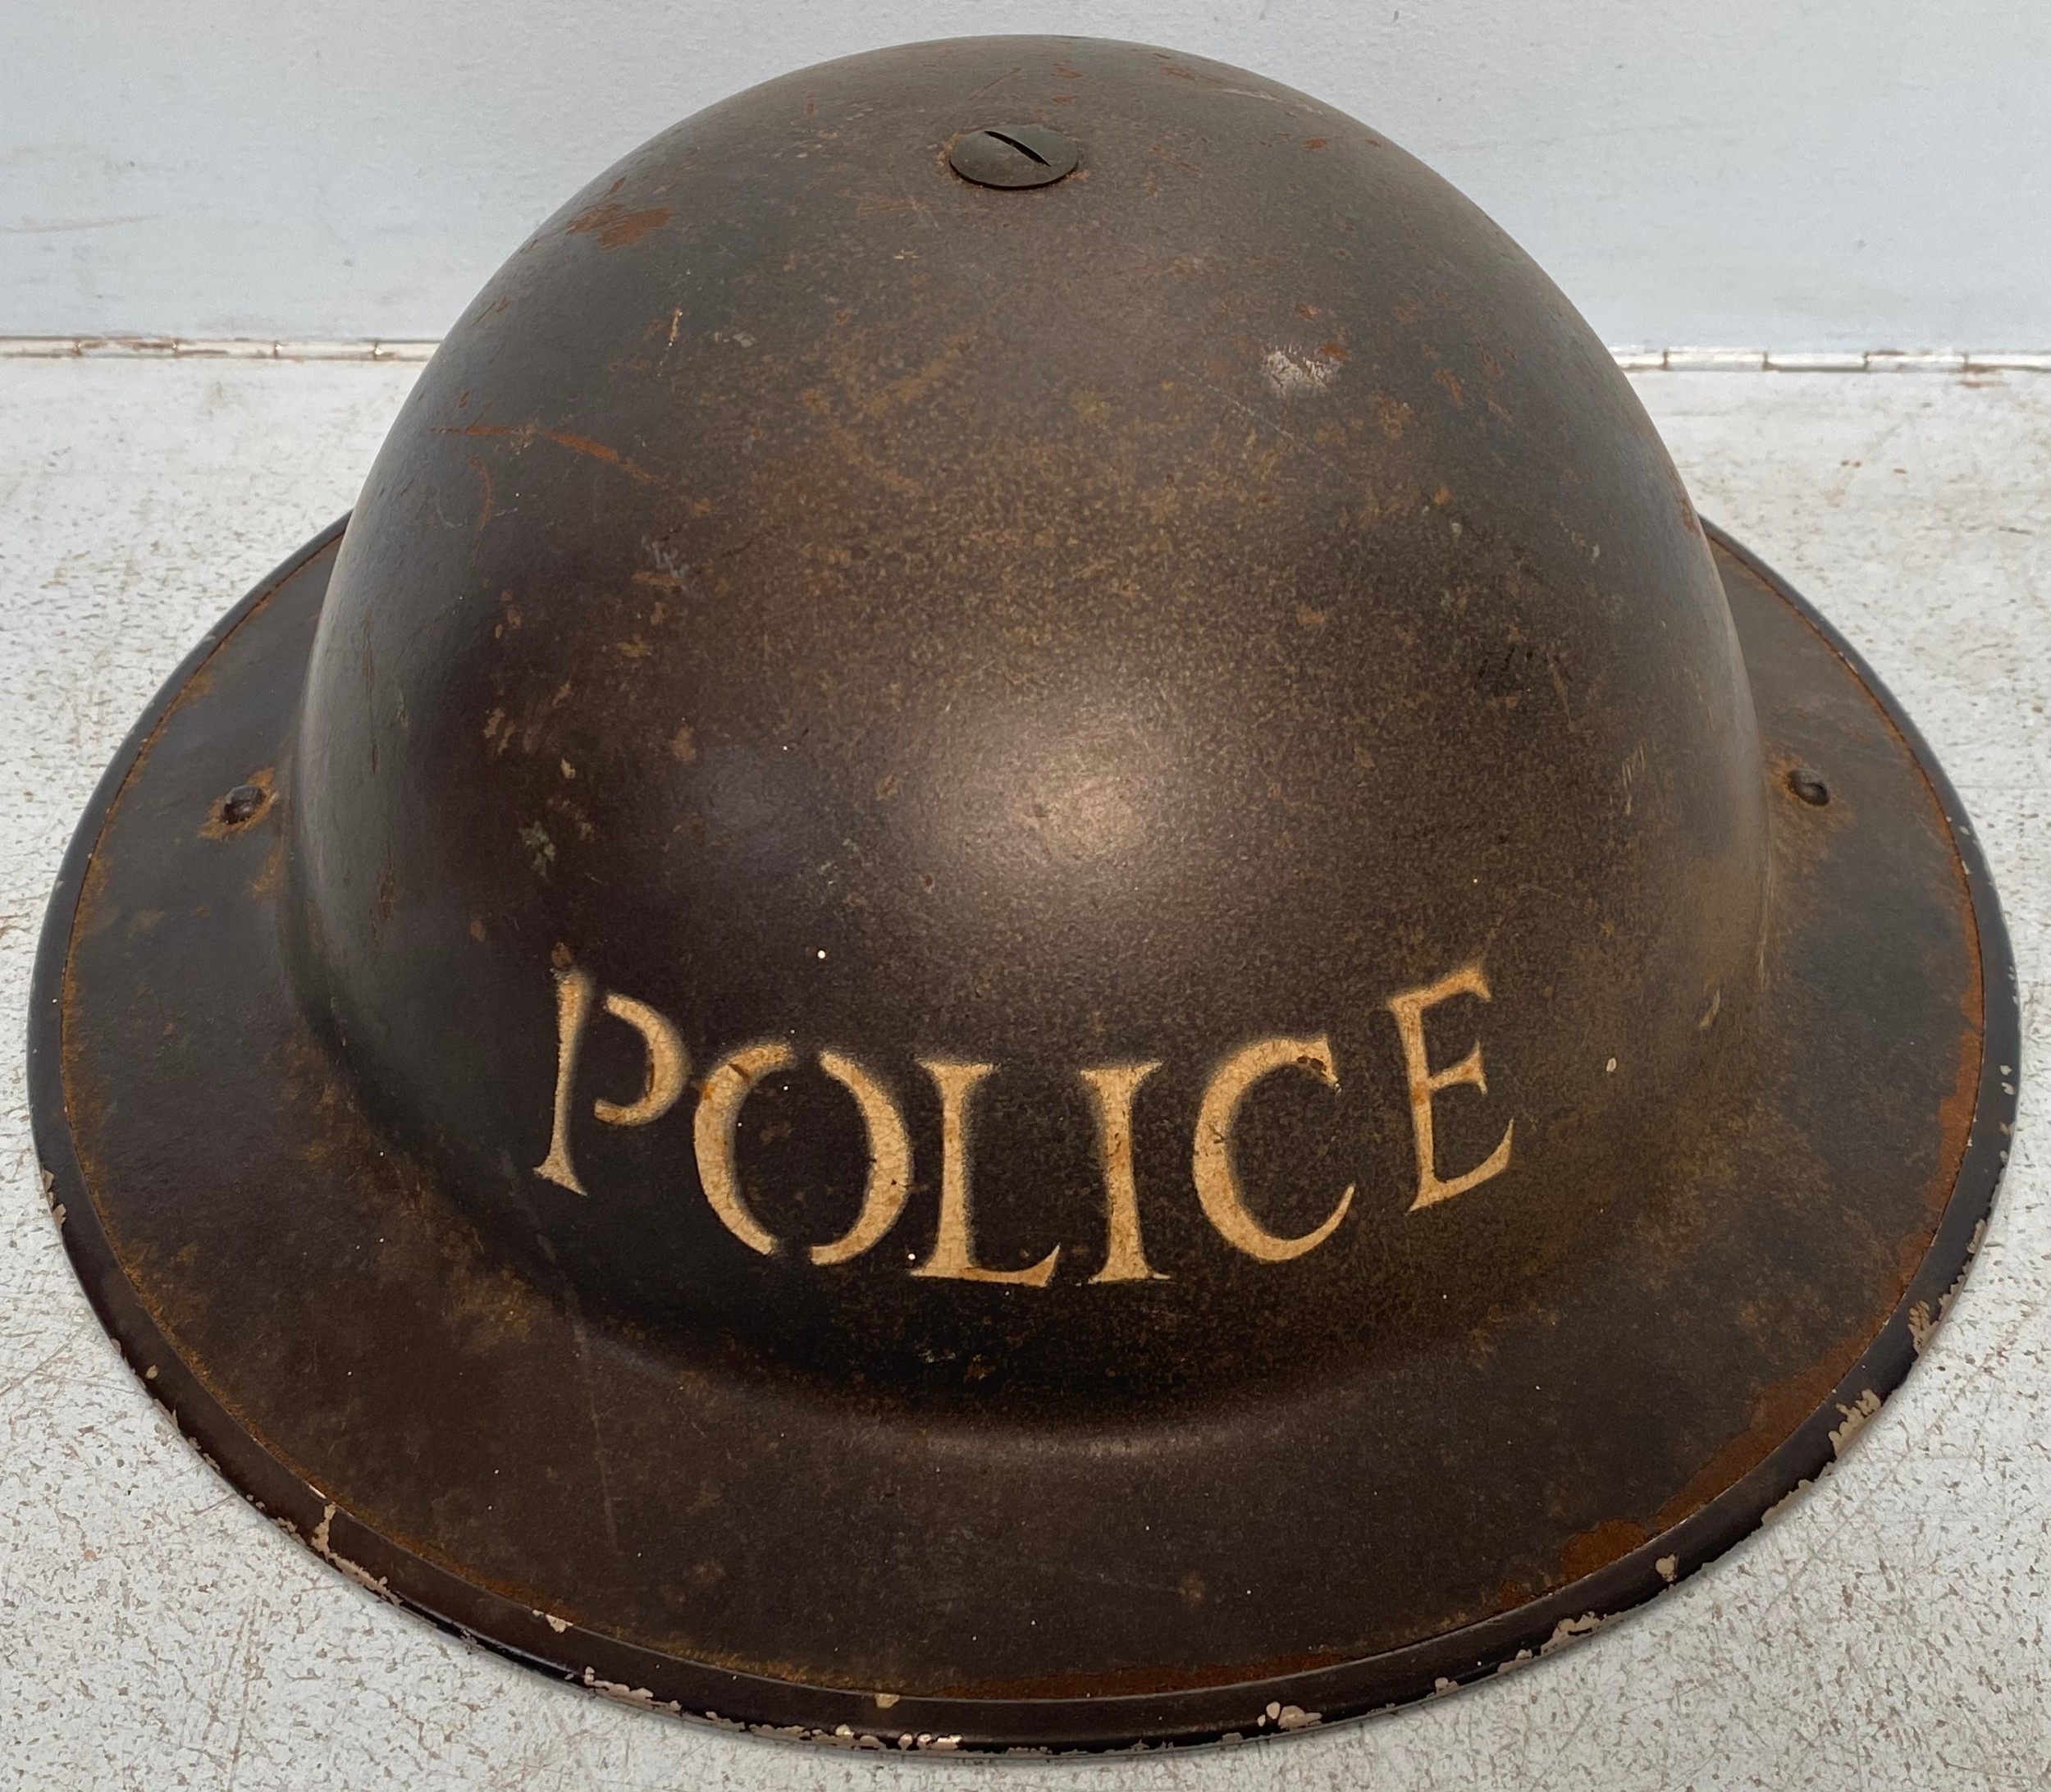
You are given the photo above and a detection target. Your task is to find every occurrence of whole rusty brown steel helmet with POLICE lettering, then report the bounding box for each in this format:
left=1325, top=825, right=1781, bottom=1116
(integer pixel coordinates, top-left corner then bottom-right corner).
left=31, top=39, right=2018, bottom=1749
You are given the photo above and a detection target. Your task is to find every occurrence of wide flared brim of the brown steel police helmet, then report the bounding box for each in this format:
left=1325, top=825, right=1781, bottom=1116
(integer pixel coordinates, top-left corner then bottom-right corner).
left=31, top=523, right=2021, bottom=1749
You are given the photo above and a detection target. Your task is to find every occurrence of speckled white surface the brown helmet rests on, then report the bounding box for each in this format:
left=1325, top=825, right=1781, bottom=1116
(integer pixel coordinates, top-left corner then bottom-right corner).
left=0, top=361, right=2051, bottom=1792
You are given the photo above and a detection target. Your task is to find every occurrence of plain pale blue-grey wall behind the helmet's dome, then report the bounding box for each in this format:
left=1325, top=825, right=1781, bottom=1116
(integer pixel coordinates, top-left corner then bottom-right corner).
left=0, top=0, right=2051, bottom=349
